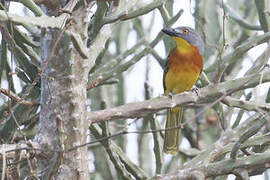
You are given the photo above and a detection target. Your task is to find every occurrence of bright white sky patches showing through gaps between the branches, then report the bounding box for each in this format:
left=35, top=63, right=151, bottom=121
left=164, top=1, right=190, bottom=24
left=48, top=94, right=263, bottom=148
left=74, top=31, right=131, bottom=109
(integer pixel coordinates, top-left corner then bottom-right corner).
left=7, top=0, right=269, bottom=180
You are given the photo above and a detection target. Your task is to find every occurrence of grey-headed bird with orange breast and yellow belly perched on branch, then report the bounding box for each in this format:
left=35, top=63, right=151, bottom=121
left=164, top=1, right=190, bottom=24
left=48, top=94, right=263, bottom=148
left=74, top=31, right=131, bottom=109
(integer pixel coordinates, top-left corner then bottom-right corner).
left=162, top=26, right=205, bottom=155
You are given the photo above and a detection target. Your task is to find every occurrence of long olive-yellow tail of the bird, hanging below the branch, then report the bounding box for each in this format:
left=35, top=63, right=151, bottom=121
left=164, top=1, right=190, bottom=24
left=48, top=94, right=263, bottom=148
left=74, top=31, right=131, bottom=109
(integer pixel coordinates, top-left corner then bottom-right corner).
left=163, top=107, right=182, bottom=155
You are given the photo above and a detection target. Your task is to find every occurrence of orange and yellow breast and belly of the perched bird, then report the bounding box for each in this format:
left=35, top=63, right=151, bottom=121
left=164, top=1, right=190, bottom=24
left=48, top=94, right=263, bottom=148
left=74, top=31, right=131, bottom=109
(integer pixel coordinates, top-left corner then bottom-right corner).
left=165, top=46, right=203, bottom=95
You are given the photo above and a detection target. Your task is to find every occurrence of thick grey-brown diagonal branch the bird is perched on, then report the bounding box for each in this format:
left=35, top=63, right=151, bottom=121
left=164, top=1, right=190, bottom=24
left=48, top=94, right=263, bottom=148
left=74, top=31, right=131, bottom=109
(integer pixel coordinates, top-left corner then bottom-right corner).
left=88, top=72, right=270, bottom=125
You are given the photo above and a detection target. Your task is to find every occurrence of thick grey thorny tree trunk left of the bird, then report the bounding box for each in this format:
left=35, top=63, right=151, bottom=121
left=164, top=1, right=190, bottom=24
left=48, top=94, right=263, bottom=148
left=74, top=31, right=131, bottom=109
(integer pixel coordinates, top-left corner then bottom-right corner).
left=35, top=8, right=90, bottom=179
